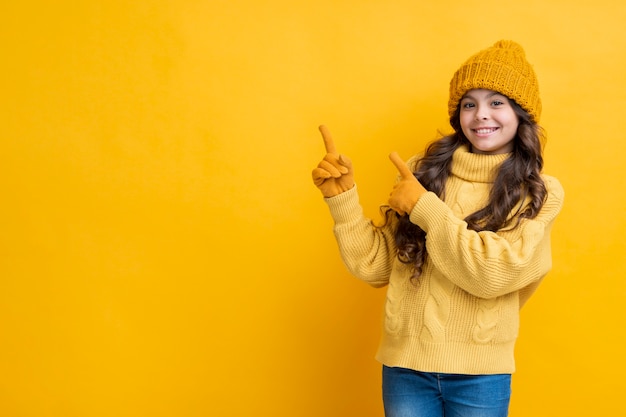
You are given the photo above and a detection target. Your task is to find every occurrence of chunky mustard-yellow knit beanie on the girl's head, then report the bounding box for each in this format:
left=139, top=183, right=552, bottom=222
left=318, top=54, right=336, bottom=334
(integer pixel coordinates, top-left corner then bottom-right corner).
left=448, top=40, right=541, bottom=122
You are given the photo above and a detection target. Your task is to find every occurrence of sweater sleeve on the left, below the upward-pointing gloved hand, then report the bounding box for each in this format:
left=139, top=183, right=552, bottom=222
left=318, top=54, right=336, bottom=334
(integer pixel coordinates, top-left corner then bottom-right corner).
left=324, top=186, right=396, bottom=287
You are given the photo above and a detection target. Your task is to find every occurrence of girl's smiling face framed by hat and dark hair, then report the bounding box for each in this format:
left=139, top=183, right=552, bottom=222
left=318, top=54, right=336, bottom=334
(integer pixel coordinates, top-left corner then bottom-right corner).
left=459, top=89, right=519, bottom=155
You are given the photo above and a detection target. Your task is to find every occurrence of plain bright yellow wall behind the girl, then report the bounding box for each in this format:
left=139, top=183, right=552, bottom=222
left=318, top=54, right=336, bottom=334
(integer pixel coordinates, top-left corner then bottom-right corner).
left=0, top=0, right=626, bottom=417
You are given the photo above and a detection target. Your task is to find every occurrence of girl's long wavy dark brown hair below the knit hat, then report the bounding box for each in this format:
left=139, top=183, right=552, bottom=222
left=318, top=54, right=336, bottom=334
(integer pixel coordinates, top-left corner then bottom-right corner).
left=385, top=100, right=547, bottom=278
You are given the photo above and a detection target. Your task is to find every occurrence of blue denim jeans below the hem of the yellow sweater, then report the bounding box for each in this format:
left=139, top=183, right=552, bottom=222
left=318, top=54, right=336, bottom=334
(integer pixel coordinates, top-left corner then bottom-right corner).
left=383, top=366, right=511, bottom=417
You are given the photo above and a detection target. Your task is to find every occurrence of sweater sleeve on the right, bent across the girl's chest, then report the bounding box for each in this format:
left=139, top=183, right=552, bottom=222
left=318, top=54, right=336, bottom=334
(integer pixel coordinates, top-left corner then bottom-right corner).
left=411, top=176, right=564, bottom=299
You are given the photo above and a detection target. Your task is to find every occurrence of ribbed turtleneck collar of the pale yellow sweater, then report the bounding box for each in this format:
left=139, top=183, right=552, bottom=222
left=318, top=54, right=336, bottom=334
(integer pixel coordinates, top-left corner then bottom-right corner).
left=452, top=145, right=511, bottom=183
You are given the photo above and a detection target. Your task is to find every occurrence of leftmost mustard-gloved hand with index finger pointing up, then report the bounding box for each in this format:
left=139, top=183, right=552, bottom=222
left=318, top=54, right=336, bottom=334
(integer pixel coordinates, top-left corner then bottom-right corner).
left=312, top=125, right=354, bottom=198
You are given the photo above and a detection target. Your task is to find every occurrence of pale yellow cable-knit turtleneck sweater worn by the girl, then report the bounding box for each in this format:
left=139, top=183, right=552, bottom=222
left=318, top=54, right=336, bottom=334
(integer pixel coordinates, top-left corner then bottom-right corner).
left=325, top=147, right=563, bottom=375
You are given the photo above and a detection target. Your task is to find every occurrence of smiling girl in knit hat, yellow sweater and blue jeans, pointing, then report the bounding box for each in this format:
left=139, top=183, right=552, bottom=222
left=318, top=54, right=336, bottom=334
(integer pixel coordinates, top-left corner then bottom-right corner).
left=313, top=41, right=563, bottom=417
